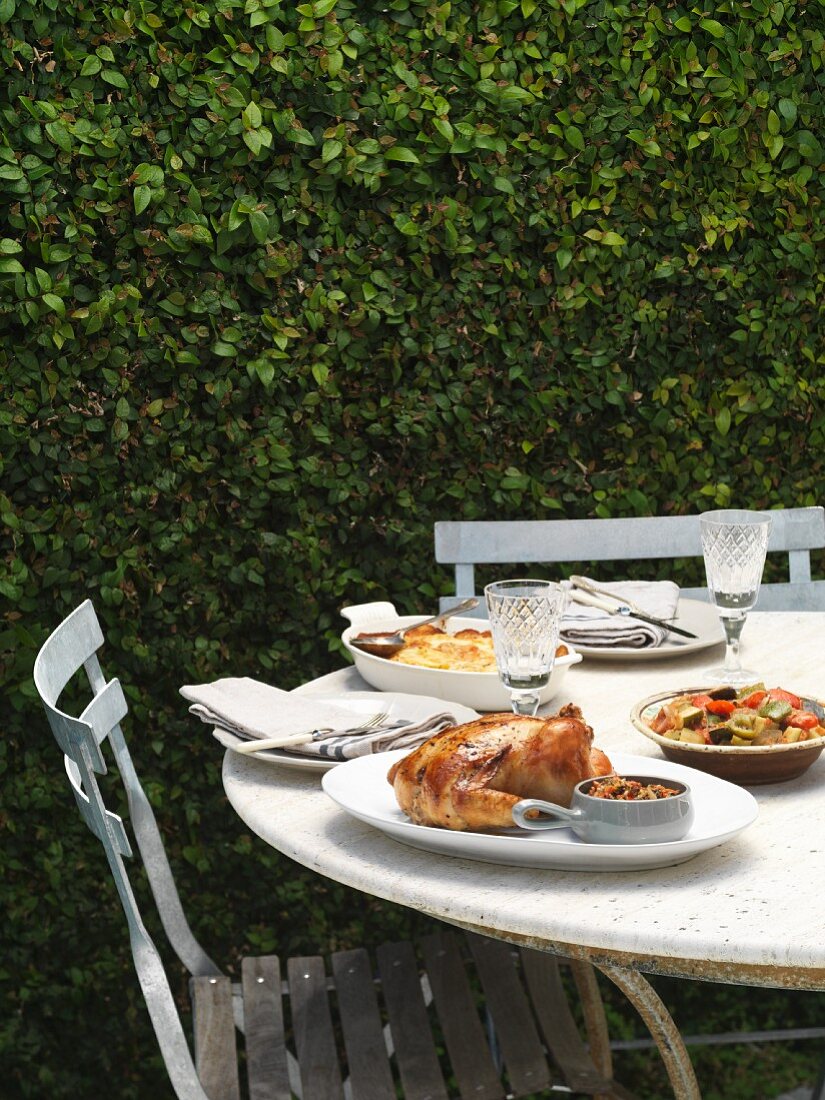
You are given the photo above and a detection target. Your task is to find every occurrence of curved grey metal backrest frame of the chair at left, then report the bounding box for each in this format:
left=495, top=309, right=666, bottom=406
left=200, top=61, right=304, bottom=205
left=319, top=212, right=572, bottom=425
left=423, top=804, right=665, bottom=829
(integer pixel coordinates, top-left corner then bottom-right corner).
left=34, top=600, right=221, bottom=1100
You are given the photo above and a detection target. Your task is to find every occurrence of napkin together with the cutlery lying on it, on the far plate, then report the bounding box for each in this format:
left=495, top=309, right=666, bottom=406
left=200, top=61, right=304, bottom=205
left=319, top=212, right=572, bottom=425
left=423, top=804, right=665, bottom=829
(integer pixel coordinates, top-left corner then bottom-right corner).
left=561, top=576, right=695, bottom=649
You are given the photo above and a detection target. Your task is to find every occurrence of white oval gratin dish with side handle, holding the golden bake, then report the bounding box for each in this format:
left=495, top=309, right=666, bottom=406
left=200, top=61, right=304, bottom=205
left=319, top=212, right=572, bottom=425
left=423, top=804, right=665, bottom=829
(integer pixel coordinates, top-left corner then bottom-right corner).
left=341, top=601, right=582, bottom=712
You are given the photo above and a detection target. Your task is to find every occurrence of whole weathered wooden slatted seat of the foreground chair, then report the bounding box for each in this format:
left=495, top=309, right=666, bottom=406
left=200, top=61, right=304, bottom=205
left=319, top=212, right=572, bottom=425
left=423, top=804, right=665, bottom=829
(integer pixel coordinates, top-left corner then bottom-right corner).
left=193, top=931, right=633, bottom=1100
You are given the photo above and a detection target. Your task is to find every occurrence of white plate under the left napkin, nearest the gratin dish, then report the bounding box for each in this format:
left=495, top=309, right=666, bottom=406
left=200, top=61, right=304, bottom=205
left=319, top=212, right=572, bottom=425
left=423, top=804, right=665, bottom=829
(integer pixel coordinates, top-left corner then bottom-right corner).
left=212, top=691, right=479, bottom=771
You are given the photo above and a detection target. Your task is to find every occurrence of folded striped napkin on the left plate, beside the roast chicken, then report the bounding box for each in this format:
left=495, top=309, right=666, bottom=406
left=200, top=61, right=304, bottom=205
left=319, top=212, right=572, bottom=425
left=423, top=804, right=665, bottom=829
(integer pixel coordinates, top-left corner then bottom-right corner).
left=180, top=677, right=455, bottom=760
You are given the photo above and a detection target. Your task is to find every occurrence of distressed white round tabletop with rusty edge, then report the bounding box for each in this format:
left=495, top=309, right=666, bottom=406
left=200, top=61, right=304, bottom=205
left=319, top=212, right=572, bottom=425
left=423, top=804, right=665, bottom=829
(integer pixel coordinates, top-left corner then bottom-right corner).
left=223, top=613, right=825, bottom=989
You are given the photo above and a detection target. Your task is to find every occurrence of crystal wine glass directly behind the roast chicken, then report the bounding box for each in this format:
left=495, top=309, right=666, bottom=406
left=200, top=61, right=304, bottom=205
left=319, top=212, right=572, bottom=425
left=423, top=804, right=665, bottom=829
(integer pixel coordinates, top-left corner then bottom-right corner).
left=484, top=580, right=569, bottom=715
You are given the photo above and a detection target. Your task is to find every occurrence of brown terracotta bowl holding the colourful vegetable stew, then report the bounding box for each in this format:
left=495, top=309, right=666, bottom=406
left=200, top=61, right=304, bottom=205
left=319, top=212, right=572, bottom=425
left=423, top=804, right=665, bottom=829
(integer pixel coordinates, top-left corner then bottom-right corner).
left=630, top=688, right=825, bottom=787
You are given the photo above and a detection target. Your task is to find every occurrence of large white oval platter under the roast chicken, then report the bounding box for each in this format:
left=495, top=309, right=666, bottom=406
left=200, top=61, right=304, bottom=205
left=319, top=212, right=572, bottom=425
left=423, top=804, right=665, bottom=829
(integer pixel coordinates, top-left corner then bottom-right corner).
left=321, top=749, right=758, bottom=871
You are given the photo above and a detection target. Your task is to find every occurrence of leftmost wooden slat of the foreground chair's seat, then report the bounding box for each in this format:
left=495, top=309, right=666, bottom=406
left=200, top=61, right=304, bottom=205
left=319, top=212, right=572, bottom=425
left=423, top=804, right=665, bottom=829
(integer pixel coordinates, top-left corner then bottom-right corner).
left=191, top=977, right=241, bottom=1100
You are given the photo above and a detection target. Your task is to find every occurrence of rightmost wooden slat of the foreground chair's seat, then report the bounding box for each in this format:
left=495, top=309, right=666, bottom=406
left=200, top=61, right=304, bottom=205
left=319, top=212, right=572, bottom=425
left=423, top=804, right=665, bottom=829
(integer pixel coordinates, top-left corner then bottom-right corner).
left=521, top=948, right=629, bottom=1095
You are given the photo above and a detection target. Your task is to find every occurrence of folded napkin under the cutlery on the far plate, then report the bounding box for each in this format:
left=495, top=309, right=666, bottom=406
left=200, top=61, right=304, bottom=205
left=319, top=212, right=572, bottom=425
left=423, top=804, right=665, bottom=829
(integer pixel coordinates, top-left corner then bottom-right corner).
left=561, top=578, right=679, bottom=649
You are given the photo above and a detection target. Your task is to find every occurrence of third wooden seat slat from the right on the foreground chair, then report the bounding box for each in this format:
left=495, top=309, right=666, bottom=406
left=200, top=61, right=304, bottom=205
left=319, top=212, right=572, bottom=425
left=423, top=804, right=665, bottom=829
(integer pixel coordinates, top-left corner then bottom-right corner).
left=422, top=932, right=505, bottom=1100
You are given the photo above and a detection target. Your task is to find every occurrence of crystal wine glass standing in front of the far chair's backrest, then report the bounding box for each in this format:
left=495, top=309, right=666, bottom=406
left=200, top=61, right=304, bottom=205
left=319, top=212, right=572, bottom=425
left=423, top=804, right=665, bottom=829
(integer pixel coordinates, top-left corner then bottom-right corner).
left=700, top=508, right=771, bottom=688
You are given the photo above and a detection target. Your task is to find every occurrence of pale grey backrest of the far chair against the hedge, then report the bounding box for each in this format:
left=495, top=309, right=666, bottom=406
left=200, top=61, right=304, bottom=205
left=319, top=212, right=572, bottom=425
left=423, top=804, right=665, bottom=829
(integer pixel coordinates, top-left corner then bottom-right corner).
left=435, top=507, right=825, bottom=616
